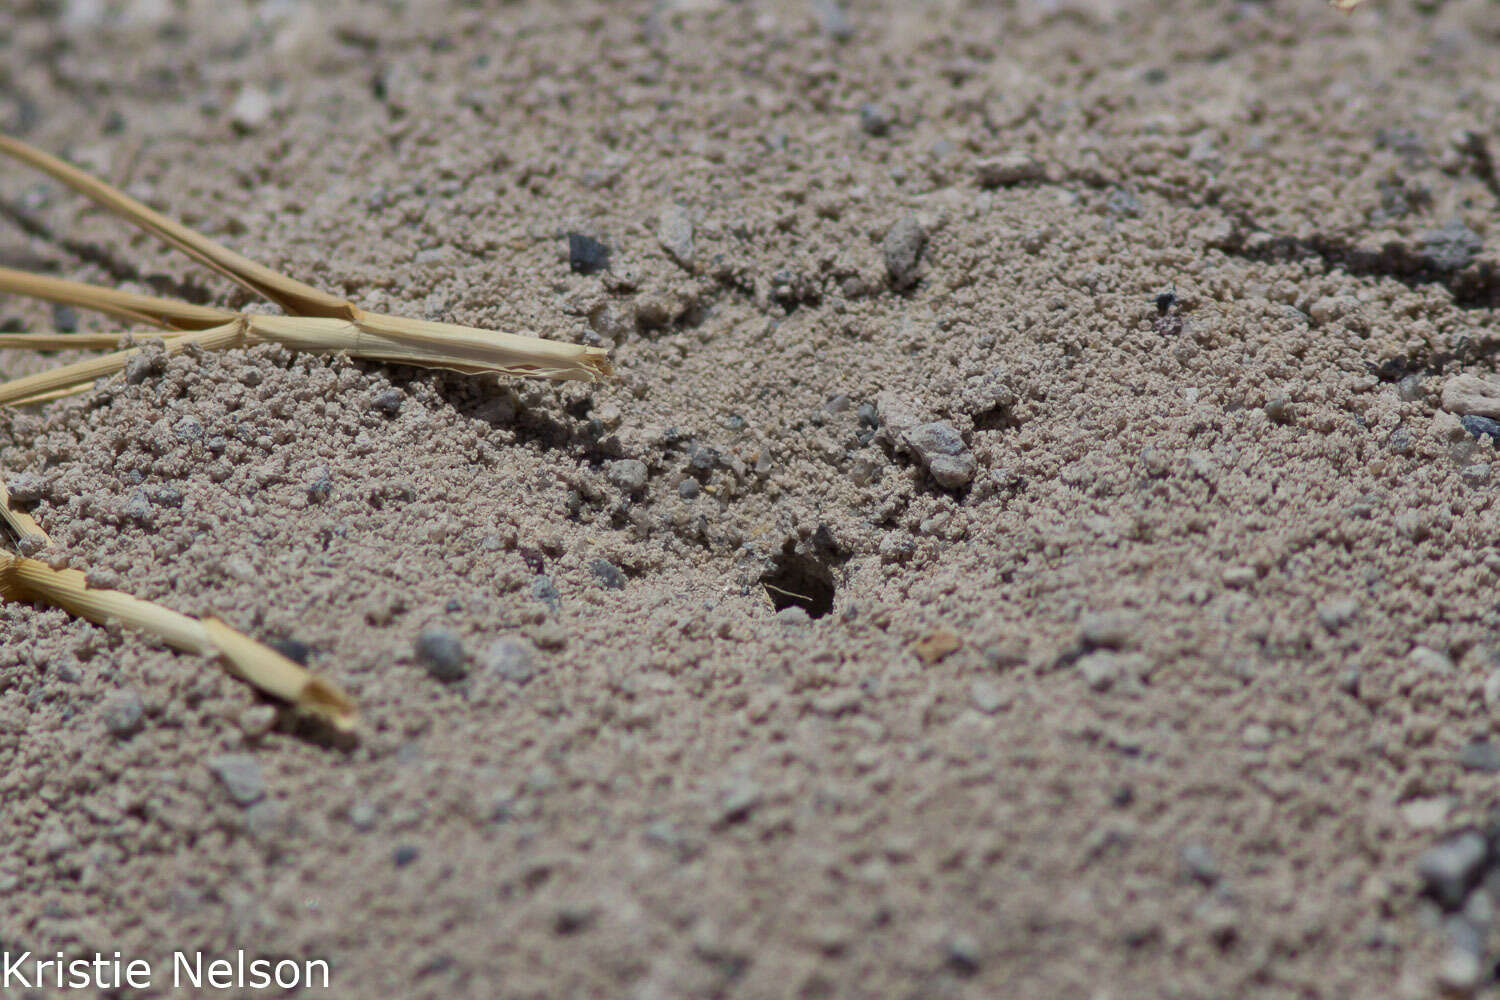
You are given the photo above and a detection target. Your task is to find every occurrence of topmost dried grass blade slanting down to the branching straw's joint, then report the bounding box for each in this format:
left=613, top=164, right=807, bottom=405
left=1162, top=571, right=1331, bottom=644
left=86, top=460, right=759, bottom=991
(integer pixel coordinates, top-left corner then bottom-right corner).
left=0, top=135, right=354, bottom=319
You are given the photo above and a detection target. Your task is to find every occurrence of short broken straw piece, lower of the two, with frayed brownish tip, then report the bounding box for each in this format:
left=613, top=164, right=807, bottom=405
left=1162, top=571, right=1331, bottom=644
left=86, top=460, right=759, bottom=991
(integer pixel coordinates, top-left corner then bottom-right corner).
left=0, top=552, right=359, bottom=732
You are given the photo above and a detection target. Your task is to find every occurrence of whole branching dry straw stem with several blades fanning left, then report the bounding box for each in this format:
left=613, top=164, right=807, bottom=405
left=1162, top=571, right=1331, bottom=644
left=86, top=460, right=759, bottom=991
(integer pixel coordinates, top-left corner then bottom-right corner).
left=0, top=135, right=614, bottom=403
